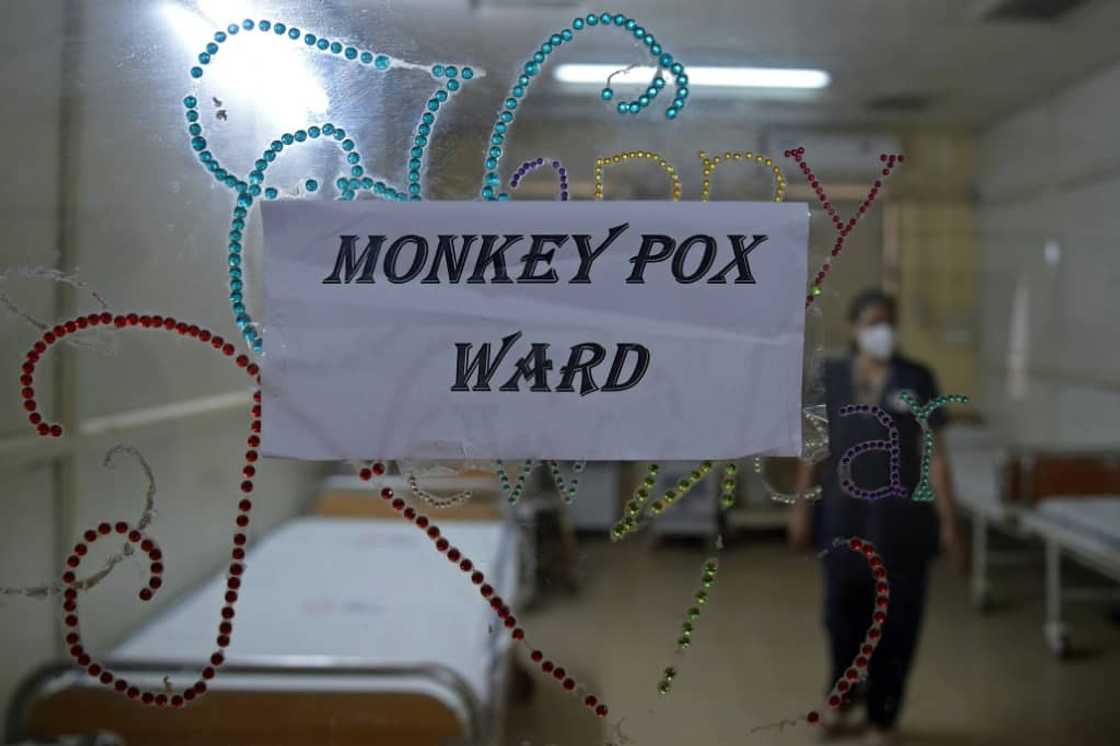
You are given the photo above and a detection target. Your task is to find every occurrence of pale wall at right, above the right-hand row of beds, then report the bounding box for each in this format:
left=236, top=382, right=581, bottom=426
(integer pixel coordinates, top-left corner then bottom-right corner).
left=977, top=59, right=1120, bottom=448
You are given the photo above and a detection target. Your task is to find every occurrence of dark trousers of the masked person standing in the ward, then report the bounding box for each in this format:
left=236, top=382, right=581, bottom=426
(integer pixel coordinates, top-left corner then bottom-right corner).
left=824, top=551, right=927, bottom=728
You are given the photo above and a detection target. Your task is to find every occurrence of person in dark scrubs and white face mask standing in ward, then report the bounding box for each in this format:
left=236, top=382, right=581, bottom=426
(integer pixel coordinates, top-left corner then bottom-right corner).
left=790, top=290, right=963, bottom=744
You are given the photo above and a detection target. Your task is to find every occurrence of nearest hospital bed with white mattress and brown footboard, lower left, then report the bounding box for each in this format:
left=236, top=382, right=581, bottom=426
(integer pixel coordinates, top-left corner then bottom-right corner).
left=7, top=514, right=517, bottom=746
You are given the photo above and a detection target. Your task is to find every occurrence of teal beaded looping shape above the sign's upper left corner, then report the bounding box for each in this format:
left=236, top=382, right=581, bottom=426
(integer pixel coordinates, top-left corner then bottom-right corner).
left=183, top=18, right=482, bottom=353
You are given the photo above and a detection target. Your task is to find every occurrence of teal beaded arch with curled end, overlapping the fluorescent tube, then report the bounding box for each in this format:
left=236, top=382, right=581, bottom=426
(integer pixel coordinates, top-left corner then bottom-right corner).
left=479, top=13, right=689, bottom=201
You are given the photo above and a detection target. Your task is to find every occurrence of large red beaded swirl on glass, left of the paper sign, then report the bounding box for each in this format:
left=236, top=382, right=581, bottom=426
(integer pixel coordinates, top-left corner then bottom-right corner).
left=19, top=311, right=261, bottom=707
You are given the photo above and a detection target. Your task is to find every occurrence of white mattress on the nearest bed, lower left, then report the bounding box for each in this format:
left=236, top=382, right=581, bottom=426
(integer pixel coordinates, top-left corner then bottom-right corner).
left=105, top=516, right=517, bottom=718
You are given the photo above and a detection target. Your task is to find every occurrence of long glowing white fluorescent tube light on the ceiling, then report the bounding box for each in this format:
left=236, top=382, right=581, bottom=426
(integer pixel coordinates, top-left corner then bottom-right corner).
left=556, top=64, right=832, bottom=88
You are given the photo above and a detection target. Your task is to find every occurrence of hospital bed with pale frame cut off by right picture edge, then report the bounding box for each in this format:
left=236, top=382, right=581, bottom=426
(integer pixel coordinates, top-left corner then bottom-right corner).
left=1023, top=494, right=1120, bottom=655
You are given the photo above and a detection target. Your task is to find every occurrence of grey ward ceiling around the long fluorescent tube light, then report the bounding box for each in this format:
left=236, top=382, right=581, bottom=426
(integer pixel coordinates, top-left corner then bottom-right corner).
left=356, top=0, right=1120, bottom=128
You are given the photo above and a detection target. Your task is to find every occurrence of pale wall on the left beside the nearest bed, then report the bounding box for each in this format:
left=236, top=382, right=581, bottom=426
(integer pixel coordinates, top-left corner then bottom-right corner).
left=0, top=1, right=321, bottom=708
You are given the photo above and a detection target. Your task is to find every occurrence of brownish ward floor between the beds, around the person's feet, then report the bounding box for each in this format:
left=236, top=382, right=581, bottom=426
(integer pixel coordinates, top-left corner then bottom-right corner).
left=506, top=530, right=1120, bottom=746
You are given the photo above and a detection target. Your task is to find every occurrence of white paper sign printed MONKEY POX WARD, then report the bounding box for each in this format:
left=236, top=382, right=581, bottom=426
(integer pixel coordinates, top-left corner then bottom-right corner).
left=261, top=201, right=809, bottom=460
